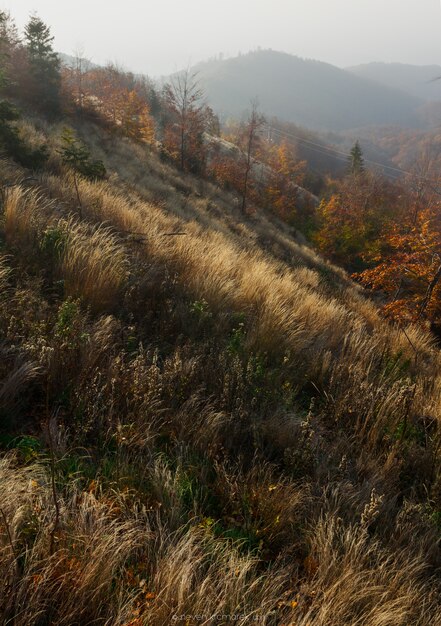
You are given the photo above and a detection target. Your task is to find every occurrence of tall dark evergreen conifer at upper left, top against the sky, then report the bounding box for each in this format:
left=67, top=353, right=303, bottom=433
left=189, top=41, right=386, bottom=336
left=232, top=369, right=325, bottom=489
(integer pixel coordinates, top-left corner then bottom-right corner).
left=25, top=15, right=61, bottom=117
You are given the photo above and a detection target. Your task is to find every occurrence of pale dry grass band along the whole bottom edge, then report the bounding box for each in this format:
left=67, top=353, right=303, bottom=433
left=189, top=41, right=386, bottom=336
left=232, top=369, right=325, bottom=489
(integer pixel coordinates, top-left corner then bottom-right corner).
left=0, top=457, right=440, bottom=626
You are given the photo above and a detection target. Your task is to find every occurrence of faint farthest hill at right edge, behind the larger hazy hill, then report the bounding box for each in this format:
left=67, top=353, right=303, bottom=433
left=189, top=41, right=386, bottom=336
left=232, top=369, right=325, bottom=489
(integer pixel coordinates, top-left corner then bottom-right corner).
left=346, top=63, right=441, bottom=100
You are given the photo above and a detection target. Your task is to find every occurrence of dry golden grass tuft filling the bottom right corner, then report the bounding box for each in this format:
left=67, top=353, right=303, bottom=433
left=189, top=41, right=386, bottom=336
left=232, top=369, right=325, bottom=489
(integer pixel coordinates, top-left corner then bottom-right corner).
left=294, top=508, right=441, bottom=626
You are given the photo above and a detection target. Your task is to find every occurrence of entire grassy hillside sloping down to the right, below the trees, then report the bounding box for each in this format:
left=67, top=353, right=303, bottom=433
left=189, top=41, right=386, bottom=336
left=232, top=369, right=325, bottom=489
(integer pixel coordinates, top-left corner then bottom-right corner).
left=0, top=113, right=441, bottom=626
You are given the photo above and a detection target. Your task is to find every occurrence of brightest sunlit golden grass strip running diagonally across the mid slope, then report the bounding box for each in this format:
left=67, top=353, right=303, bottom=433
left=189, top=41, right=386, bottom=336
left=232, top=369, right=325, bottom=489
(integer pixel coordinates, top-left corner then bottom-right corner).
left=37, top=168, right=426, bottom=360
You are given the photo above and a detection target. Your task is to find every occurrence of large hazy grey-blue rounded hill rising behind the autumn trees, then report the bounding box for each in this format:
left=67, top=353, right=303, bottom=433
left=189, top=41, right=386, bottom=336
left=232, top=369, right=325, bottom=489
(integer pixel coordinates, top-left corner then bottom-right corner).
left=195, top=50, right=421, bottom=131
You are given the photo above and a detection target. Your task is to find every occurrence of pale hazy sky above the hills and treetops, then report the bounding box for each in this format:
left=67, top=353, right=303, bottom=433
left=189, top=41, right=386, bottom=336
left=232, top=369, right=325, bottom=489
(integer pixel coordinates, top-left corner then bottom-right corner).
left=6, top=0, right=441, bottom=76
